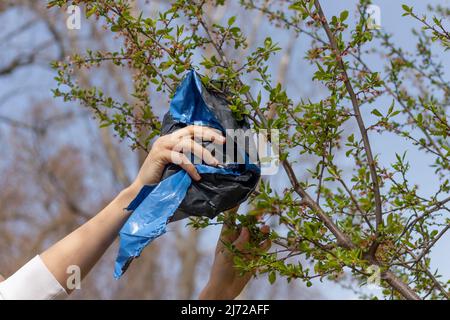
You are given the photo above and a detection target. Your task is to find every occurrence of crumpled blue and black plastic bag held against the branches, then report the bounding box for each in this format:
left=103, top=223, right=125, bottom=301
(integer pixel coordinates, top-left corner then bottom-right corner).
left=114, top=70, right=260, bottom=278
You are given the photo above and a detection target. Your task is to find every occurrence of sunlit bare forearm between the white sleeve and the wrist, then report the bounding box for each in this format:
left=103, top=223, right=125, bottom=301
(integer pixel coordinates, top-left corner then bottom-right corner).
left=40, top=187, right=139, bottom=292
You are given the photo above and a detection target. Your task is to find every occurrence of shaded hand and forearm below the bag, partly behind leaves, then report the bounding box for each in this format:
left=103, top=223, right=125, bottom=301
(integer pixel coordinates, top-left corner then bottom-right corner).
left=199, top=224, right=271, bottom=300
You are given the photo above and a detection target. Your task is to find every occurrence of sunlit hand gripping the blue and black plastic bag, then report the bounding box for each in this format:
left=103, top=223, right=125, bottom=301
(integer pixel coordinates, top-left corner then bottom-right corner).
left=133, top=125, right=225, bottom=190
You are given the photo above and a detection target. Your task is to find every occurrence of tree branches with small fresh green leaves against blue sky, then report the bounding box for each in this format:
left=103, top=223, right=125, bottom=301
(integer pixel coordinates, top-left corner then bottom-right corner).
left=49, top=0, right=450, bottom=299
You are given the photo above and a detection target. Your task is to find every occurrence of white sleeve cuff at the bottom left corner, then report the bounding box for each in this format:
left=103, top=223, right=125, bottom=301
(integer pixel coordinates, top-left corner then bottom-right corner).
left=0, top=256, right=67, bottom=300
